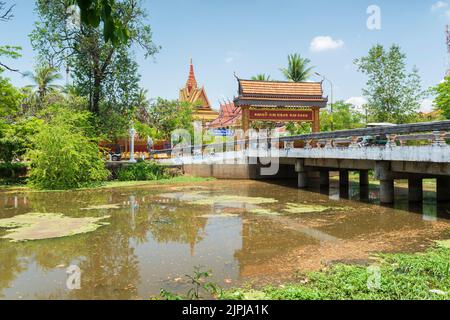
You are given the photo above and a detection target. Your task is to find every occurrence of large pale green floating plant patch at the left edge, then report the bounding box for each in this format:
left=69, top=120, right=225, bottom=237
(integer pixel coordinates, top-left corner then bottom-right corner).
left=0, top=213, right=109, bottom=242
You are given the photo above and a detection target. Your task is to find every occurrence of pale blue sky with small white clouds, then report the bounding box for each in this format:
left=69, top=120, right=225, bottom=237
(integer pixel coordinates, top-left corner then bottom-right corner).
left=0, top=0, right=450, bottom=111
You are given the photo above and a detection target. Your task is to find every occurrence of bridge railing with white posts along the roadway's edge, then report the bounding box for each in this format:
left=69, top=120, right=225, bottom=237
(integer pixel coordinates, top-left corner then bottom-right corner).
left=153, top=120, right=450, bottom=156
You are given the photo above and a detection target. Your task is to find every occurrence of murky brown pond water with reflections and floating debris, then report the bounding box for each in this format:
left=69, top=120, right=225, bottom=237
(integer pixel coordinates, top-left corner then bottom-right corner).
left=0, top=181, right=450, bottom=299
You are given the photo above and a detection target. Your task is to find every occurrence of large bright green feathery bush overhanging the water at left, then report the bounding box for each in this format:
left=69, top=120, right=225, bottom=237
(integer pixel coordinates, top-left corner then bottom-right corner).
left=29, top=109, right=109, bottom=190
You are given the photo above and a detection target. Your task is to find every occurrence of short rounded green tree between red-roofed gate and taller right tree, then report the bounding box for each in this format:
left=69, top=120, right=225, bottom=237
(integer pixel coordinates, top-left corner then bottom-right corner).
left=320, top=101, right=365, bottom=132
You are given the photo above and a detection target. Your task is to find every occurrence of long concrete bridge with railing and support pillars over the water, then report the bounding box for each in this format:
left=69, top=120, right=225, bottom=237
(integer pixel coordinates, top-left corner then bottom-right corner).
left=162, top=121, right=450, bottom=203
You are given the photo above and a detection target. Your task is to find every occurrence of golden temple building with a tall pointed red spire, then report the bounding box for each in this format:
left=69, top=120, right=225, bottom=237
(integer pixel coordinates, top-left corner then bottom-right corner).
left=180, top=60, right=219, bottom=125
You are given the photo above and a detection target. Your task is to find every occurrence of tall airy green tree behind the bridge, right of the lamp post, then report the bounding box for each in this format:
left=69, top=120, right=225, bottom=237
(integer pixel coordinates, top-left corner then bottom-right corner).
left=355, top=44, right=424, bottom=123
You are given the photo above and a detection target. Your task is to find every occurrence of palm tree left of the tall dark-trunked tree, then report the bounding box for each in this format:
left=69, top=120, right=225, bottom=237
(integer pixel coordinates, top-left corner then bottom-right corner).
left=25, top=65, right=62, bottom=102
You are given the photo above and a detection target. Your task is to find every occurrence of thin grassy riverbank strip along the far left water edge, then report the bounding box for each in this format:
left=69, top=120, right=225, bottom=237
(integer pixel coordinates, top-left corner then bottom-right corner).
left=0, top=176, right=215, bottom=193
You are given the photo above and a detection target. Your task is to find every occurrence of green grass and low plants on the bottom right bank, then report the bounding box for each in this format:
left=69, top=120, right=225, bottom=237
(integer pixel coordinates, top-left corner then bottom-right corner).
left=221, top=248, right=450, bottom=300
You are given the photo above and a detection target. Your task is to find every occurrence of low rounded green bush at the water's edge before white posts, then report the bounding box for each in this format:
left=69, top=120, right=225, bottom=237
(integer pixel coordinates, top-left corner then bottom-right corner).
left=117, top=162, right=169, bottom=181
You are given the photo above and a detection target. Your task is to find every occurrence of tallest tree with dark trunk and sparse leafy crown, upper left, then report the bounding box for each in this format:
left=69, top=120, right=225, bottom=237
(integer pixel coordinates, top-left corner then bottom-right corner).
left=31, top=0, right=159, bottom=116
